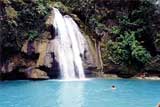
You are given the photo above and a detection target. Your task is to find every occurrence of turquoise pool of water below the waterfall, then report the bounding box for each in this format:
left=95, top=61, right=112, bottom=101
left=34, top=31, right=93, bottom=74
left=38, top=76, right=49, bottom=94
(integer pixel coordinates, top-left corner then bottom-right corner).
left=0, top=79, right=160, bottom=107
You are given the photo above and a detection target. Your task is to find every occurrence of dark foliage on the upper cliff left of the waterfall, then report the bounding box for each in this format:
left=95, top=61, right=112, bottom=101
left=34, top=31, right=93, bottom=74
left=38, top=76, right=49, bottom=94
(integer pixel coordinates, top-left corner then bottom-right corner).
left=0, top=0, right=51, bottom=48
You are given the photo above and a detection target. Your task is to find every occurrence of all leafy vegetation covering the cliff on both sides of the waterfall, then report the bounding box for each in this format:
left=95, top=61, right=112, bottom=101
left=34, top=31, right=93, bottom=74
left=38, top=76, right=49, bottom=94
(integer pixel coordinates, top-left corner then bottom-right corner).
left=0, top=0, right=160, bottom=77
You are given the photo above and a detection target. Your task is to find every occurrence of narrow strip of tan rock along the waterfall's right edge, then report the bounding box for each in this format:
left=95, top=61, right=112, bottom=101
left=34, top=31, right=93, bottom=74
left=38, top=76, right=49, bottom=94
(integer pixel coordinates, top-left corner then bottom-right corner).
left=70, top=14, right=100, bottom=74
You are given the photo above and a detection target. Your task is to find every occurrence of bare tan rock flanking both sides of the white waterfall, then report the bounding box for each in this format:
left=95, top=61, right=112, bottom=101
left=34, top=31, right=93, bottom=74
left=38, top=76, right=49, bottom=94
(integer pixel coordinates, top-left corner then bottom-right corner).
left=0, top=11, right=97, bottom=80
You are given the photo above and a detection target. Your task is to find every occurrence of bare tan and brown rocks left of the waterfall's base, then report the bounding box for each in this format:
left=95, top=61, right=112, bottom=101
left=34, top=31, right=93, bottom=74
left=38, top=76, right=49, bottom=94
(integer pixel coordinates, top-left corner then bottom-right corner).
left=1, top=41, right=49, bottom=80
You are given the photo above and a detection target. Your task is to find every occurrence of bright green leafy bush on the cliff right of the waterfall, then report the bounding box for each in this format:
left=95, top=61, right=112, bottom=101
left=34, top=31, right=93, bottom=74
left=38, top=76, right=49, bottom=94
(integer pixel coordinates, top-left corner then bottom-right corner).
left=107, top=32, right=151, bottom=71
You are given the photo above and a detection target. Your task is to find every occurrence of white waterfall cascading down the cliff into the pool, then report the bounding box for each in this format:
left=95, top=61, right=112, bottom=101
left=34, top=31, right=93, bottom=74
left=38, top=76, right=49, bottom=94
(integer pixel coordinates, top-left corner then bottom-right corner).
left=52, top=8, right=86, bottom=79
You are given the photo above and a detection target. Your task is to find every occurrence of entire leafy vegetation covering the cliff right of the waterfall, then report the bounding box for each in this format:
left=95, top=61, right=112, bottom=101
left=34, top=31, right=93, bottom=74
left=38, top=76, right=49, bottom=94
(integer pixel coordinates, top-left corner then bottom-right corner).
left=62, top=0, right=160, bottom=71
